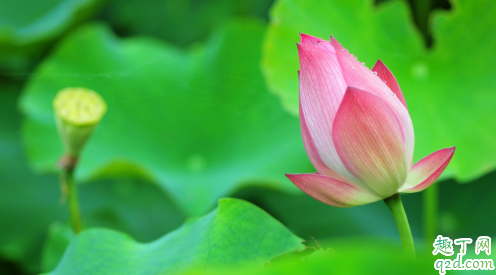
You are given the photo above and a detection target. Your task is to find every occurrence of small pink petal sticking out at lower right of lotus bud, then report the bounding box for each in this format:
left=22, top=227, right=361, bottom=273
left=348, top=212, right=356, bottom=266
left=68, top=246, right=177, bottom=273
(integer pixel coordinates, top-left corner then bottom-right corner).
left=400, top=147, right=455, bottom=193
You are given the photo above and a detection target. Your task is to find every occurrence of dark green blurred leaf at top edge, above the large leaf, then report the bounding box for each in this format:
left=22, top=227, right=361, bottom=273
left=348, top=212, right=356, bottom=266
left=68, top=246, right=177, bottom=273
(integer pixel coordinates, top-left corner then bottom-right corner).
left=103, top=0, right=273, bottom=46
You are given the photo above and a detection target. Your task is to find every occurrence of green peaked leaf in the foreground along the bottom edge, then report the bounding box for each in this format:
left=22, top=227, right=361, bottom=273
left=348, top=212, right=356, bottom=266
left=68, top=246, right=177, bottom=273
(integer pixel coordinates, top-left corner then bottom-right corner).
left=45, top=199, right=305, bottom=275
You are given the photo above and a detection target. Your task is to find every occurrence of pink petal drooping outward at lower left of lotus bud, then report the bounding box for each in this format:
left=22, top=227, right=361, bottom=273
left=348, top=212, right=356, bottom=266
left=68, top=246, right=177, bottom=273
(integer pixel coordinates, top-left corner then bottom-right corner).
left=286, top=173, right=381, bottom=207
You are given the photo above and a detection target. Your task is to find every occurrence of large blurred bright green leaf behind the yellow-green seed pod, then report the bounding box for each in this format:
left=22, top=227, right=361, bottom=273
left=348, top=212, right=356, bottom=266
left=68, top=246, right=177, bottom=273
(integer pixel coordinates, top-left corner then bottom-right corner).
left=21, top=21, right=313, bottom=215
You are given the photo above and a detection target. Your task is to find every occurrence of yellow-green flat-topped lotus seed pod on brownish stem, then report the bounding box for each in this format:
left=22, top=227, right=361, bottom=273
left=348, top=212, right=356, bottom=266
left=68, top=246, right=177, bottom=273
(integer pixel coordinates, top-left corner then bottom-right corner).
left=53, top=88, right=107, bottom=157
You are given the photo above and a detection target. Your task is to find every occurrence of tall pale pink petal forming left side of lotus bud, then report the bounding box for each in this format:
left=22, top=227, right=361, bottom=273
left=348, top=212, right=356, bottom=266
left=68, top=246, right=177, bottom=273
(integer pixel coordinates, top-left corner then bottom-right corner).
left=298, top=35, right=359, bottom=185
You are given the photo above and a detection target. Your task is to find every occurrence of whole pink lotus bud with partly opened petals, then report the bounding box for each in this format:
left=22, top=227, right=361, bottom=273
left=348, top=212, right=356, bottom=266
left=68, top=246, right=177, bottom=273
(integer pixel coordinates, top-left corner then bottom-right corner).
left=286, top=34, right=455, bottom=207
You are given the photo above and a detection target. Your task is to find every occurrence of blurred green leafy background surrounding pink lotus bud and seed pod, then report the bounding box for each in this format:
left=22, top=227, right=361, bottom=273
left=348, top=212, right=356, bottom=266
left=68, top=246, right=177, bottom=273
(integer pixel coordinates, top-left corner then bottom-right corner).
left=0, top=0, right=496, bottom=274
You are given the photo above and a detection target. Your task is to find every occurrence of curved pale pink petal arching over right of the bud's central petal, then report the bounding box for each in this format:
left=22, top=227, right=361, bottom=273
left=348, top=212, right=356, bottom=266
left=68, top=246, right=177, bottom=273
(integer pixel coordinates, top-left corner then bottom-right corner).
left=331, top=37, right=415, bottom=167
